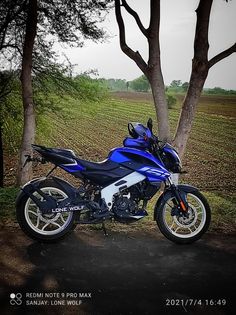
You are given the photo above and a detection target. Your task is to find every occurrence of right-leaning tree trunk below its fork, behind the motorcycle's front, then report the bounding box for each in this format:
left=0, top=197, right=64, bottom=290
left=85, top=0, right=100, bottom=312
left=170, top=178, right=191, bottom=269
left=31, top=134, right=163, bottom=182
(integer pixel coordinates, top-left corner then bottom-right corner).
left=173, top=60, right=208, bottom=158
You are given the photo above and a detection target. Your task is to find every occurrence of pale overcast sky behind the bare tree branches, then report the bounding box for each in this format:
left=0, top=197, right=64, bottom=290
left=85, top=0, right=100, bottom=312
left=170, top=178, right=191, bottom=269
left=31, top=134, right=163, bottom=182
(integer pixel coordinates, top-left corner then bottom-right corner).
left=56, top=0, right=236, bottom=89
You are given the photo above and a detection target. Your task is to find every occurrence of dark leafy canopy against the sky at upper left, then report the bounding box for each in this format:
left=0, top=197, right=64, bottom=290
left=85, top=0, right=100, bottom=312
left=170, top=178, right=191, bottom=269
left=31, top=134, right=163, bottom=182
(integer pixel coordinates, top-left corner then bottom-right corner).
left=0, top=0, right=112, bottom=70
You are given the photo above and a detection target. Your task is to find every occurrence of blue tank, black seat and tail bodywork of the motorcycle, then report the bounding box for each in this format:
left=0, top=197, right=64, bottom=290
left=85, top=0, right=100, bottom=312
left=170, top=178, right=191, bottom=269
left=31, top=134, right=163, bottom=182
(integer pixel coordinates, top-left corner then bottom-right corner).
left=33, top=145, right=170, bottom=189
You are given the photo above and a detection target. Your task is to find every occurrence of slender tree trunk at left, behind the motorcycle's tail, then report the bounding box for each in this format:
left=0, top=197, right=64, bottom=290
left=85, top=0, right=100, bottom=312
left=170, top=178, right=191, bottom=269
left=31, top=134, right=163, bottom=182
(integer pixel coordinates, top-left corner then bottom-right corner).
left=17, top=0, right=37, bottom=185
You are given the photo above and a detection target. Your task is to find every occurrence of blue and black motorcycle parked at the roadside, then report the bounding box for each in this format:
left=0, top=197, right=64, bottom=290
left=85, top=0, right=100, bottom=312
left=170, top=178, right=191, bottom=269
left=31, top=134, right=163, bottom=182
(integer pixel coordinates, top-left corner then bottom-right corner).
left=16, top=119, right=211, bottom=244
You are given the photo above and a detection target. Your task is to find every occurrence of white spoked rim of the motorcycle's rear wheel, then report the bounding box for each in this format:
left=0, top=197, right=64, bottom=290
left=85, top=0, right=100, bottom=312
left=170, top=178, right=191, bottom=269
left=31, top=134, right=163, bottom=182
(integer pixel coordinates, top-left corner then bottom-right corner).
left=24, top=187, right=73, bottom=235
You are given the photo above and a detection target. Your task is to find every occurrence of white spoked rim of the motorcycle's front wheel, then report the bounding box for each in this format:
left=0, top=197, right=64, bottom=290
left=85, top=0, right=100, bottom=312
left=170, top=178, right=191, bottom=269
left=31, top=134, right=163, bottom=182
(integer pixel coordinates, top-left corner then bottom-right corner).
left=163, top=194, right=206, bottom=238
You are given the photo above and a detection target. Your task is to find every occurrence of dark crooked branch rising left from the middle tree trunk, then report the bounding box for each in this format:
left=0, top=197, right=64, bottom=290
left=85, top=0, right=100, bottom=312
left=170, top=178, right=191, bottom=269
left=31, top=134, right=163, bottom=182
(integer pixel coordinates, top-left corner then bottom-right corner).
left=115, top=0, right=147, bottom=75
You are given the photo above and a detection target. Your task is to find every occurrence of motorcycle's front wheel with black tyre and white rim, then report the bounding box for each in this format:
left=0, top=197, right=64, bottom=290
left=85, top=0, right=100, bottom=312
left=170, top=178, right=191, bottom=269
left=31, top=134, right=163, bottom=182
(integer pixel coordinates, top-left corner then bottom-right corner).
left=156, top=188, right=211, bottom=244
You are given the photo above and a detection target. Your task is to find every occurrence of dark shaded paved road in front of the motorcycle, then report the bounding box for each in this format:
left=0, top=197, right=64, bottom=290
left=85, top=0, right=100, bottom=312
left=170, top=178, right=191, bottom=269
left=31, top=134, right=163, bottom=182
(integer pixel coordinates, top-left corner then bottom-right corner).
left=0, top=228, right=236, bottom=315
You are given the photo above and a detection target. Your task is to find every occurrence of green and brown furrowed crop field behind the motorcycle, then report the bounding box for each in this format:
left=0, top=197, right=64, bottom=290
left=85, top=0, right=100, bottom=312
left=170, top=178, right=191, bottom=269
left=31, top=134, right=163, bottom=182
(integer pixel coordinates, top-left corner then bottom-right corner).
left=0, top=92, right=236, bottom=232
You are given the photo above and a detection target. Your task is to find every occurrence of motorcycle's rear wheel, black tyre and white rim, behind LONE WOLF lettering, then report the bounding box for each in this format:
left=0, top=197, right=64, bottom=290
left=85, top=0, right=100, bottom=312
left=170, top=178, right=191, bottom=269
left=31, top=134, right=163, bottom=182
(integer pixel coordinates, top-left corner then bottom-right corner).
left=16, top=179, right=76, bottom=243
